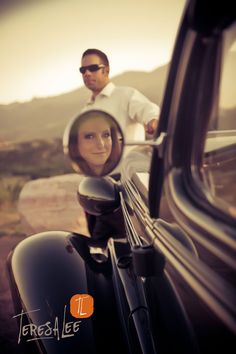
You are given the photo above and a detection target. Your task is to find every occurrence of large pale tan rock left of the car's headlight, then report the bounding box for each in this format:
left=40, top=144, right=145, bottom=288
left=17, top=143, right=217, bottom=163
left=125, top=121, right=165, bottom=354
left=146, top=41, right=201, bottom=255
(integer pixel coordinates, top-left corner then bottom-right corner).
left=18, top=174, right=89, bottom=235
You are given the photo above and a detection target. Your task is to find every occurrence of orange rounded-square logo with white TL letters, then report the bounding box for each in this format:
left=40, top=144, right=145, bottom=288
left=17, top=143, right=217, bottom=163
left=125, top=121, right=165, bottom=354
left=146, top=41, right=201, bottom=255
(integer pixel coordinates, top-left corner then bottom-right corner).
left=70, top=294, right=94, bottom=318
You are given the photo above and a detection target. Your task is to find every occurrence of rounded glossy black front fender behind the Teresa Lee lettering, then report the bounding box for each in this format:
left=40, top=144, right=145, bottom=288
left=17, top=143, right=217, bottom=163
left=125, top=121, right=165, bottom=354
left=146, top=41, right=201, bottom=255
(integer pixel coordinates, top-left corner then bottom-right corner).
left=8, top=231, right=127, bottom=354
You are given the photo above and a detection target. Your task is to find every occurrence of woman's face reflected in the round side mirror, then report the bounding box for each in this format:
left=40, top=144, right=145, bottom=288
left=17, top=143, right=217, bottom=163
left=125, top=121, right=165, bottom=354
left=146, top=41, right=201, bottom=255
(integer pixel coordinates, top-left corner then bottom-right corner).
left=78, top=117, right=112, bottom=172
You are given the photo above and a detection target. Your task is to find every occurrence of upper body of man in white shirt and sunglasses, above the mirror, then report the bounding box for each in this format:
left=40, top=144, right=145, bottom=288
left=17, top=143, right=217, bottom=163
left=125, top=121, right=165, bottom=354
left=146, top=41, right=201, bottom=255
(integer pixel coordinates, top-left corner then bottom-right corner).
left=80, top=49, right=160, bottom=140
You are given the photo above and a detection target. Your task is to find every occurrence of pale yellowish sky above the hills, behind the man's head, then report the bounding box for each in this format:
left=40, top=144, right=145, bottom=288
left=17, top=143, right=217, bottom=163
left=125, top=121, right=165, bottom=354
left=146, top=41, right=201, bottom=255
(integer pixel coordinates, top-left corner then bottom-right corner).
left=0, top=0, right=186, bottom=104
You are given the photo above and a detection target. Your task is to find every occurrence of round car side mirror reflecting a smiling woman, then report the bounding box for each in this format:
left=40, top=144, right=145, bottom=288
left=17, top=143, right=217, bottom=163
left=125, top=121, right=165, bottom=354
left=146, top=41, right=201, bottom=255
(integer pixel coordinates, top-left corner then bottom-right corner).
left=63, top=110, right=124, bottom=176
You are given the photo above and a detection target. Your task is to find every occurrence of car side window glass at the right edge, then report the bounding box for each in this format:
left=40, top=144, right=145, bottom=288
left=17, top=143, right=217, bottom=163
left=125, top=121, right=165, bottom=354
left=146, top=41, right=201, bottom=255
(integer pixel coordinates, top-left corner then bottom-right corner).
left=202, top=24, right=236, bottom=218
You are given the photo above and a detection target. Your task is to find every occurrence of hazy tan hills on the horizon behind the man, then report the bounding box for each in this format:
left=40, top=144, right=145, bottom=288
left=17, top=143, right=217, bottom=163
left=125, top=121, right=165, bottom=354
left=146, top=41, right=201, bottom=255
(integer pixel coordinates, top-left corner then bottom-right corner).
left=0, top=65, right=168, bottom=142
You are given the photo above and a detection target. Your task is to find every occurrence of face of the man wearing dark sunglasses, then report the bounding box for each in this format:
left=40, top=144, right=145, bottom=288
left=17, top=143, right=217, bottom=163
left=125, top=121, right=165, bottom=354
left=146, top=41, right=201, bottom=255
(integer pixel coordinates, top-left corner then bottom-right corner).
left=81, top=54, right=109, bottom=94
